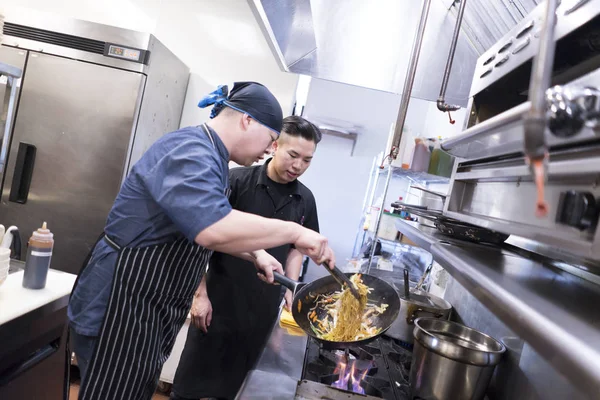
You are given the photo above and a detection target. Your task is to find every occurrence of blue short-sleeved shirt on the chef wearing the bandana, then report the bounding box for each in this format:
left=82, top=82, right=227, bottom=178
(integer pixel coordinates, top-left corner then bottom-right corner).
left=68, top=123, right=231, bottom=336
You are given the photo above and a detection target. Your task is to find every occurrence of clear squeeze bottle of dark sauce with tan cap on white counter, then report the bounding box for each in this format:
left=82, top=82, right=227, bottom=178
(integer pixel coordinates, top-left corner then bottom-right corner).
left=23, top=222, right=54, bottom=289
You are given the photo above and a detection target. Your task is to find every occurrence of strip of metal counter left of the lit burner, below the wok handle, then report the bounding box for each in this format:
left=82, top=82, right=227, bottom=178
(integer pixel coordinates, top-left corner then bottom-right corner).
left=236, top=307, right=308, bottom=400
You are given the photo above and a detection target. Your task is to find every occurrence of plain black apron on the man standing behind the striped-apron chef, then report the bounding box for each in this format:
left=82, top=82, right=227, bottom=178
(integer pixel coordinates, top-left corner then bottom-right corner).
left=173, top=253, right=283, bottom=399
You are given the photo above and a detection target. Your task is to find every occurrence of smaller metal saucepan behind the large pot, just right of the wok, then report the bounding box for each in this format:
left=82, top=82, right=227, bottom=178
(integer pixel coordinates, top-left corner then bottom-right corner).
left=385, top=289, right=452, bottom=344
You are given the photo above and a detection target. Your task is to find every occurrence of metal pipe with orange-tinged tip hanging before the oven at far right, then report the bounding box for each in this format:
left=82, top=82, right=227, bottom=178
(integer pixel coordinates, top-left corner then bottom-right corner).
left=523, top=0, right=558, bottom=217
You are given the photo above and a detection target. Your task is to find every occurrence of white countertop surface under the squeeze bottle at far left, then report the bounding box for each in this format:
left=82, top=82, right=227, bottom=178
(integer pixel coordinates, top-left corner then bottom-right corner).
left=0, top=261, right=77, bottom=325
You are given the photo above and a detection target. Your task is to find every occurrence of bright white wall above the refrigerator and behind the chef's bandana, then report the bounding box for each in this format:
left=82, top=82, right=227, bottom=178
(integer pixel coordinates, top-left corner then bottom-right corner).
left=0, top=0, right=297, bottom=126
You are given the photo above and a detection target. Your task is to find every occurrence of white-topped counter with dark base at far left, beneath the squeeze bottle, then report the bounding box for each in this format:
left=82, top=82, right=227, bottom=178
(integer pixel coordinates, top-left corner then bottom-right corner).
left=0, top=261, right=76, bottom=399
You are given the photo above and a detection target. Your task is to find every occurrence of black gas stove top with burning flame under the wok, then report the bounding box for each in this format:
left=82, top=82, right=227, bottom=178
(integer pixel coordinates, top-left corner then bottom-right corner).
left=296, top=336, right=412, bottom=400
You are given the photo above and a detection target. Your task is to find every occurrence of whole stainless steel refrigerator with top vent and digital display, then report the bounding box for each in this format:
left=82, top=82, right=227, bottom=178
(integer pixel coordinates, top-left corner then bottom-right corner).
left=0, top=10, right=189, bottom=273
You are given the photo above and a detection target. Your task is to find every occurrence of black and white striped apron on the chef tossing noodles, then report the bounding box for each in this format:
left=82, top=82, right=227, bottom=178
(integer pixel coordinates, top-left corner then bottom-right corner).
left=79, top=126, right=219, bottom=400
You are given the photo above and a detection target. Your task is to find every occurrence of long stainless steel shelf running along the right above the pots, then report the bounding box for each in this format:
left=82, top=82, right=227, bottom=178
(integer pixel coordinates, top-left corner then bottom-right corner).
left=396, top=221, right=600, bottom=397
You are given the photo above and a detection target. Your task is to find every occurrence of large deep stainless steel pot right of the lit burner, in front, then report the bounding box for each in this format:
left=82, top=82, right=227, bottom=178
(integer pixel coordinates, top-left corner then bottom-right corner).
left=410, top=318, right=506, bottom=400
